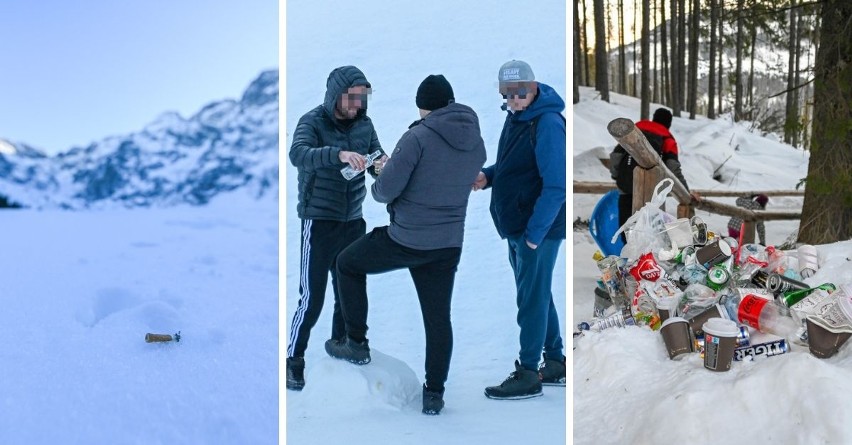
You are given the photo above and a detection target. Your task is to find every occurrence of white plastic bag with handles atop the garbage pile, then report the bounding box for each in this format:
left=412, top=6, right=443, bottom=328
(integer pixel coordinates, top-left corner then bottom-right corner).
left=612, top=178, right=676, bottom=262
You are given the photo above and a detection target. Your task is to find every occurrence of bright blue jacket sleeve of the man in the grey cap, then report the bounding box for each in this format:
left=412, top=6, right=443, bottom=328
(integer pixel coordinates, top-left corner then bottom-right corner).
left=524, top=113, right=566, bottom=245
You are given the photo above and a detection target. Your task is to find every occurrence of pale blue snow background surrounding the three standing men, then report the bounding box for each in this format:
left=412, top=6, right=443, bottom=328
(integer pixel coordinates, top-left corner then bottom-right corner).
left=281, top=0, right=569, bottom=445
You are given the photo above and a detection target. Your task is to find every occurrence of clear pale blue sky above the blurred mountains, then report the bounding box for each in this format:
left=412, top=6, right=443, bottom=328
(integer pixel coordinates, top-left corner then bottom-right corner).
left=0, top=0, right=278, bottom=154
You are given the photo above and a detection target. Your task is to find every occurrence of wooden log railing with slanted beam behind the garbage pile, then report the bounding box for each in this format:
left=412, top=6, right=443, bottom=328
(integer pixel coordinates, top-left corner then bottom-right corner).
left=574, top=118, right=805, bottom=243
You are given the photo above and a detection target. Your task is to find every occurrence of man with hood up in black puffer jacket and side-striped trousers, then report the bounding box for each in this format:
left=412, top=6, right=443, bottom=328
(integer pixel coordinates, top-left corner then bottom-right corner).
left=287, top=66, right=387, bottom=391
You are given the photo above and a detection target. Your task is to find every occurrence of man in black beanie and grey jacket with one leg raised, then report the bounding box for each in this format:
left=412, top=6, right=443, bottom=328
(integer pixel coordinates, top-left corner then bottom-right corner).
left=326, top=75, right=486, bottom=415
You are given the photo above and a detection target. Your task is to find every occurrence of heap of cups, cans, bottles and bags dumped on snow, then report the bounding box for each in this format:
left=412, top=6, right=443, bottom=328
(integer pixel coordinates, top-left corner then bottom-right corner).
left=574, top=180, right=852, bottom=371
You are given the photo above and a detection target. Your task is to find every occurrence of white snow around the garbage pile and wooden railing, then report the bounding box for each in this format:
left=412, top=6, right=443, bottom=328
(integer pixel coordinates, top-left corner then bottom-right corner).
left=571, top=88, right=852, bottom=444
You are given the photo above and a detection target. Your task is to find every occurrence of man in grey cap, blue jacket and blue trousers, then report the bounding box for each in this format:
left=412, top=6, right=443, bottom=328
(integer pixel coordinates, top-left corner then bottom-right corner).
left=473, top=60, right=566, bottom=399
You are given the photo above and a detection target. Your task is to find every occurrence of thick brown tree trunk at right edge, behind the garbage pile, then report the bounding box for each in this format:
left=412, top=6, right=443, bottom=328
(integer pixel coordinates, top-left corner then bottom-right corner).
left=799, top=0, right=852, bottom=244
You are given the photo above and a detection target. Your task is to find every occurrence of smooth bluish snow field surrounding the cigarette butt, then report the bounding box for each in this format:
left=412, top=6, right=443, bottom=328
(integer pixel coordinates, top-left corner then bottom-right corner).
left=0, top=192, right=279, bottom=444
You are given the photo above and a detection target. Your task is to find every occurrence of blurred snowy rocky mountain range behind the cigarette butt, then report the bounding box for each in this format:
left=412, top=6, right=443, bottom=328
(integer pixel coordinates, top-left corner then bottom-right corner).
left=0, top=69, right=278, bottom=209
